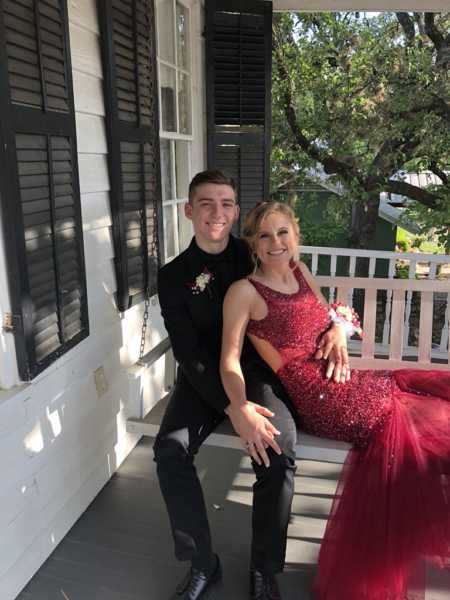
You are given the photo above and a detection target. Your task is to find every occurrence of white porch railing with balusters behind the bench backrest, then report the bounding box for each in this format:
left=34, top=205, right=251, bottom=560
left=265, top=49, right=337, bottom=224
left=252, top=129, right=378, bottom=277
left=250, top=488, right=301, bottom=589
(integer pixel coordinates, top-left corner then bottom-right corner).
left=300, top=246, right=450, bottom=358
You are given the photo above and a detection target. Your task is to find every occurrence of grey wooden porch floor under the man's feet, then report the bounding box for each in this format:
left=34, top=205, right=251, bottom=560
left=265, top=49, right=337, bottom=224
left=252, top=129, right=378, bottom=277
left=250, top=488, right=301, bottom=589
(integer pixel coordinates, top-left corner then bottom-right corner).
left=18, top=438, right=450, bottom=600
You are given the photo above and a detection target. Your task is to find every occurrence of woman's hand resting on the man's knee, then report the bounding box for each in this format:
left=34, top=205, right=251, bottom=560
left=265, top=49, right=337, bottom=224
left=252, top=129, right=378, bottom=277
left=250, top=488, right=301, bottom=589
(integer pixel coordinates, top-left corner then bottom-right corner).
left=225, top=401, right=281, bottom=467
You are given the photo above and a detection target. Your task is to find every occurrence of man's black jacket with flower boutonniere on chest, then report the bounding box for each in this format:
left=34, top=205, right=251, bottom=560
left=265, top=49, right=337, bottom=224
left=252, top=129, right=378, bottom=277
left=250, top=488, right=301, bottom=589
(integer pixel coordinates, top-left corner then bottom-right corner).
left=158, top=236, right=256, bottom=412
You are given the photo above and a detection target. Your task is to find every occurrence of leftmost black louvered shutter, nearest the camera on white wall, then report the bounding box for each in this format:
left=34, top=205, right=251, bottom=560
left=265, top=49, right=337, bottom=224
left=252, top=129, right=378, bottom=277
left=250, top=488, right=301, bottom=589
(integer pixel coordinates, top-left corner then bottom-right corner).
left=0, top=0, right=89, bottom=380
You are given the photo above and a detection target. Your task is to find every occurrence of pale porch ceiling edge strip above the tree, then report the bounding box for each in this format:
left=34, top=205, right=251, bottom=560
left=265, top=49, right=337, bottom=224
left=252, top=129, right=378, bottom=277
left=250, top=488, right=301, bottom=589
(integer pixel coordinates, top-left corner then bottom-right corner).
left=273, top=0, right=449, bottom=12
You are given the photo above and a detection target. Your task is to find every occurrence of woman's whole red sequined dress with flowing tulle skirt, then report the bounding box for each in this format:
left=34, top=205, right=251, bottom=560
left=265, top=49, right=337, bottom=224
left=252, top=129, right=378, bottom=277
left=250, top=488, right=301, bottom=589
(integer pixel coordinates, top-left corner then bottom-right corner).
left=247, top=267, right=450, bottom=600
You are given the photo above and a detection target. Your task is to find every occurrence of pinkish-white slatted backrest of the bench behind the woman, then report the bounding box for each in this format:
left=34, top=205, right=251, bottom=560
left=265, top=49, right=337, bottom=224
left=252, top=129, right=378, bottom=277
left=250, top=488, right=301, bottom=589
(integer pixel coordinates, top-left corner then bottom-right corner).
left=316, top=276, right=450, bottom=369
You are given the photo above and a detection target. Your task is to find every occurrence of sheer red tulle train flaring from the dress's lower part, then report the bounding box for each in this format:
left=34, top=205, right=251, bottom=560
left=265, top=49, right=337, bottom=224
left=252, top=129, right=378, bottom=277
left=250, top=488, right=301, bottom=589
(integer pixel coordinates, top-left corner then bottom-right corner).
left=314, top=369, right=450, bottom=600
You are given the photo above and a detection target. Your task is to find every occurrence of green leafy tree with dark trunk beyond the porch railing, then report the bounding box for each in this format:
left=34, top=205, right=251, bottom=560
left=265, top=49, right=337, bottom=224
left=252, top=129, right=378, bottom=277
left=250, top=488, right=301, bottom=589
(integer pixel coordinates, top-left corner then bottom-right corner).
left=272, top=13, right=450, bottom=248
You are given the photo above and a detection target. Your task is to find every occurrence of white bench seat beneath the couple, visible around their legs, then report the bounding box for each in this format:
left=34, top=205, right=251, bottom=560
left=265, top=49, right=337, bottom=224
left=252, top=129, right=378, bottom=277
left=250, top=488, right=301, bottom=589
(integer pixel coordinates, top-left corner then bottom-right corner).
left=127, top=393, right=351, bottom=463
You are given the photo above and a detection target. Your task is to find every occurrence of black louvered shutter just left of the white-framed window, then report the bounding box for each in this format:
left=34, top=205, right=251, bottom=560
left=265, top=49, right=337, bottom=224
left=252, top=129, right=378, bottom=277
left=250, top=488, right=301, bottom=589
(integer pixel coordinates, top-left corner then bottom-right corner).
left=98, top=0, right=163, bottom=311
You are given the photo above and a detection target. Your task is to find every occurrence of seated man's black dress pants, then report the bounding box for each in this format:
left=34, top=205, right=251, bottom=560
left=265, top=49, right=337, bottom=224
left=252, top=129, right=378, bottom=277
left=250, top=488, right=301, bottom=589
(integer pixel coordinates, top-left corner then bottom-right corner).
left=154, top=368, right=297, bottom=573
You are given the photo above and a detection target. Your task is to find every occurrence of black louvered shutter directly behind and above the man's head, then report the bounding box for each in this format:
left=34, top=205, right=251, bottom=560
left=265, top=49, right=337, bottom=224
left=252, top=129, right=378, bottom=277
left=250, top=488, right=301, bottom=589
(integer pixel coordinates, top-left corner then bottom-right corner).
left=205, top=0, right=272, bottom=230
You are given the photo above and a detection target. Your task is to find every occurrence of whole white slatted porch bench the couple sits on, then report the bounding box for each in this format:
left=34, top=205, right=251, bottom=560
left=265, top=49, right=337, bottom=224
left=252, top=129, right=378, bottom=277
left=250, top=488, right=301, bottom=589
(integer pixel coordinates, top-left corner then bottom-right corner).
left=127, top=276, right=450, bottom=463
